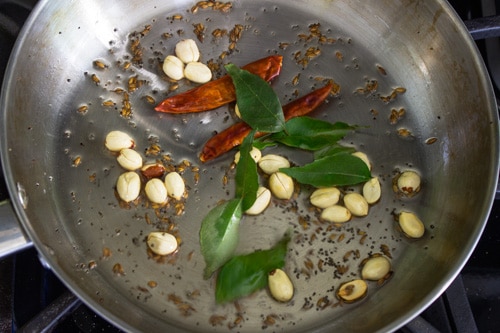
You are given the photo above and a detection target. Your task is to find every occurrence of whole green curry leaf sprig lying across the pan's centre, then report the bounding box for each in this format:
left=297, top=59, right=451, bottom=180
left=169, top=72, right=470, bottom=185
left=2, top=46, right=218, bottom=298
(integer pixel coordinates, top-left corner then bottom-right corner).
left=200, top=64, right=371, bottom=303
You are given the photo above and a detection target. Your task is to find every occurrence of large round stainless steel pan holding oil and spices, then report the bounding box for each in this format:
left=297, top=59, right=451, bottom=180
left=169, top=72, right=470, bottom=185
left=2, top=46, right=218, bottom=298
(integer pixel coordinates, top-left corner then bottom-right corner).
left=1, top=0, right=499, bottom=332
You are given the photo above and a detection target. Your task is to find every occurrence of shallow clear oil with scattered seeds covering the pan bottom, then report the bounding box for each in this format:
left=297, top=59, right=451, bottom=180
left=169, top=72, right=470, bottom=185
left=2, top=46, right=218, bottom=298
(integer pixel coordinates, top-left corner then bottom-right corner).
left=60, top=4, right=435, bottom=331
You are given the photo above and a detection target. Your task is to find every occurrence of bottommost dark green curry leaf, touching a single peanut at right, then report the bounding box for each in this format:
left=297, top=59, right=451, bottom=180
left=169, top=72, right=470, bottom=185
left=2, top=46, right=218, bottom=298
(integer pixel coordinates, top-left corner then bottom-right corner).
left=215, top=232, right=290, bottom=303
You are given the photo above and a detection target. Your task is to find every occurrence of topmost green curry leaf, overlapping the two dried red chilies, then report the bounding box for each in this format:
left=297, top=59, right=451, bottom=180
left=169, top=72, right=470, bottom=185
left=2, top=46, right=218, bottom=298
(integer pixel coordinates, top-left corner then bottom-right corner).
left=225, top=64, right=285, bottom=132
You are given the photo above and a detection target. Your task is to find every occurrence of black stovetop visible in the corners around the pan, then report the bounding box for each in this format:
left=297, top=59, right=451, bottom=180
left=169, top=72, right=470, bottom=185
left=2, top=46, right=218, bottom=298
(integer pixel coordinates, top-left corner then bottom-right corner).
left=0, top=0, right=500, bottom=333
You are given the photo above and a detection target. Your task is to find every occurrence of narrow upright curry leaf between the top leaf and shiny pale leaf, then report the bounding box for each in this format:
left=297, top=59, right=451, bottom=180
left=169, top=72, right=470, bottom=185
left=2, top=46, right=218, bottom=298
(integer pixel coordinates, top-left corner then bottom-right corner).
left=235, top=131, right=259, bottom=211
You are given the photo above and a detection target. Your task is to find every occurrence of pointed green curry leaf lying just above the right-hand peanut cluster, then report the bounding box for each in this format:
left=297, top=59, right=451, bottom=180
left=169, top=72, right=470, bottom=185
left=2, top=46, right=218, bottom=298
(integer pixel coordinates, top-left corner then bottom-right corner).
left=280, top=154, right=371, bottom=187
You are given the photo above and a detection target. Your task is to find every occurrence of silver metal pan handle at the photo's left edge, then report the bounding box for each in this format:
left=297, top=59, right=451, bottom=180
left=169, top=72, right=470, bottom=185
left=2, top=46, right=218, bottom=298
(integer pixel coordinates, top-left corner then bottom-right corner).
left=0, top=200, right=32, bottom=259
